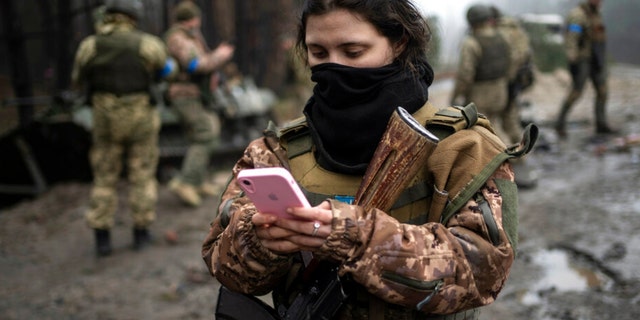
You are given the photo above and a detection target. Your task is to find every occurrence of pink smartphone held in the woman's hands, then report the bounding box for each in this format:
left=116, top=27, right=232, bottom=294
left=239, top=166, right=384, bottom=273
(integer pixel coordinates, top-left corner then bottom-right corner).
left=237, top=167, right=311, bottom=219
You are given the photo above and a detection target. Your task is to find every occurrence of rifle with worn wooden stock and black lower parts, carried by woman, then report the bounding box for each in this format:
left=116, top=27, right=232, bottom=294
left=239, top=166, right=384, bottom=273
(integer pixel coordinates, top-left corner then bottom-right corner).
left=216, top=107, right=439, bottom=320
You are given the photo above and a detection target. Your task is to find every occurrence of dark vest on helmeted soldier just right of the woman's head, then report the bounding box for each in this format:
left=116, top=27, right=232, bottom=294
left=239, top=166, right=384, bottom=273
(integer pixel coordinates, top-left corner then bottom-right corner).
left=474, top=34, right=510, bottom=81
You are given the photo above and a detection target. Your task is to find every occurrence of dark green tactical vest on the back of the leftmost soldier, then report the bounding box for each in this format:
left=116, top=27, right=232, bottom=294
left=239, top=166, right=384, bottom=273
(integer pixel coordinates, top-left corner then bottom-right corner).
left=87, top=30, right=151, bottom=95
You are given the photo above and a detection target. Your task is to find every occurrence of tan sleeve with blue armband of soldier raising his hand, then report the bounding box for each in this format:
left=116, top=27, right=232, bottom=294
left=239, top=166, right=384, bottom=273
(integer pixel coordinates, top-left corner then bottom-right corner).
left=167, top=28, right=226, bottom=74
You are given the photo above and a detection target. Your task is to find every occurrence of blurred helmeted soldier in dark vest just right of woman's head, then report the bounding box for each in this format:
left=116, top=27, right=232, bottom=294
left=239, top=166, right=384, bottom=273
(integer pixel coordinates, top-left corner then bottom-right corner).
left=451, top=4, right=510, bottom=141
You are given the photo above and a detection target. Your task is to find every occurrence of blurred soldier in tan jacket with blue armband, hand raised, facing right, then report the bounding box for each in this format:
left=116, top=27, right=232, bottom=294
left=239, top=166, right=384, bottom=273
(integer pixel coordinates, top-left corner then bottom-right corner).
left=164, top=0, right=234, bottom=207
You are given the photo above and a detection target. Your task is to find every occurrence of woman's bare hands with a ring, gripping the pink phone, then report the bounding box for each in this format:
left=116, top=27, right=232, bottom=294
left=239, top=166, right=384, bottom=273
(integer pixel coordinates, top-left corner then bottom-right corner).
left=251, top=201, right=333, bottom=254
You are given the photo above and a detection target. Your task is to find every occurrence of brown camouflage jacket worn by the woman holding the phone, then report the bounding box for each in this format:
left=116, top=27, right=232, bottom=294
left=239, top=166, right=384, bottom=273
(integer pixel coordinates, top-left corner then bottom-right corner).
left=202, top=103, right=517, bottom=314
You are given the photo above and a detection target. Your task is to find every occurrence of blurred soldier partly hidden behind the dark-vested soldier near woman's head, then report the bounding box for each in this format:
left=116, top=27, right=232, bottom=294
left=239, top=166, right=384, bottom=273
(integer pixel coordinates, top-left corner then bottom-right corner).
left=491, top=6, right=538, bottom=188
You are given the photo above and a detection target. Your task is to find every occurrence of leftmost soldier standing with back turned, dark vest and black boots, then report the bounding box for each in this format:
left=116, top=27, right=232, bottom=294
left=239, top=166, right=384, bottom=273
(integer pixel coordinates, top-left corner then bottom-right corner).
left=72, top=0, right=171, bottom=257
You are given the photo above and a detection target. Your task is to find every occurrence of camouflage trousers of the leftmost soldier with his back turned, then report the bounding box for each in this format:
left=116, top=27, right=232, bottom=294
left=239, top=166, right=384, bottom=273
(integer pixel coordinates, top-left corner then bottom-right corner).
left=86, top=94, right=160, bottom=229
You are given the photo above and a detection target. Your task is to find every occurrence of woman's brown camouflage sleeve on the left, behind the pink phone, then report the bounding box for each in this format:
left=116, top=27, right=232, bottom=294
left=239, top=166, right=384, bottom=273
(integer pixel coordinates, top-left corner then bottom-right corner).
left=202, top=139, right=292, bottom=295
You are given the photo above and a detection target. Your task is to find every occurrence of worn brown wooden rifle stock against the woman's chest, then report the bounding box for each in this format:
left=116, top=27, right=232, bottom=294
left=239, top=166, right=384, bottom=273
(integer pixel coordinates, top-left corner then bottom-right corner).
left=354, top=107, right=440, bottom=211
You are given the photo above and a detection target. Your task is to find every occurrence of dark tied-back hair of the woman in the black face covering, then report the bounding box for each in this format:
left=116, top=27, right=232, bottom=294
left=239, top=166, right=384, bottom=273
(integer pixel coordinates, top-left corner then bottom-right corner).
left=296, top=0, right=431, bottom=70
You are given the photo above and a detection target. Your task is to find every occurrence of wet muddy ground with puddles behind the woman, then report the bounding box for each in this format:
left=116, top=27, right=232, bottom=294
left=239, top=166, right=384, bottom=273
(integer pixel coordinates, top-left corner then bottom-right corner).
left=0, top=65, right=640, bottom=320
